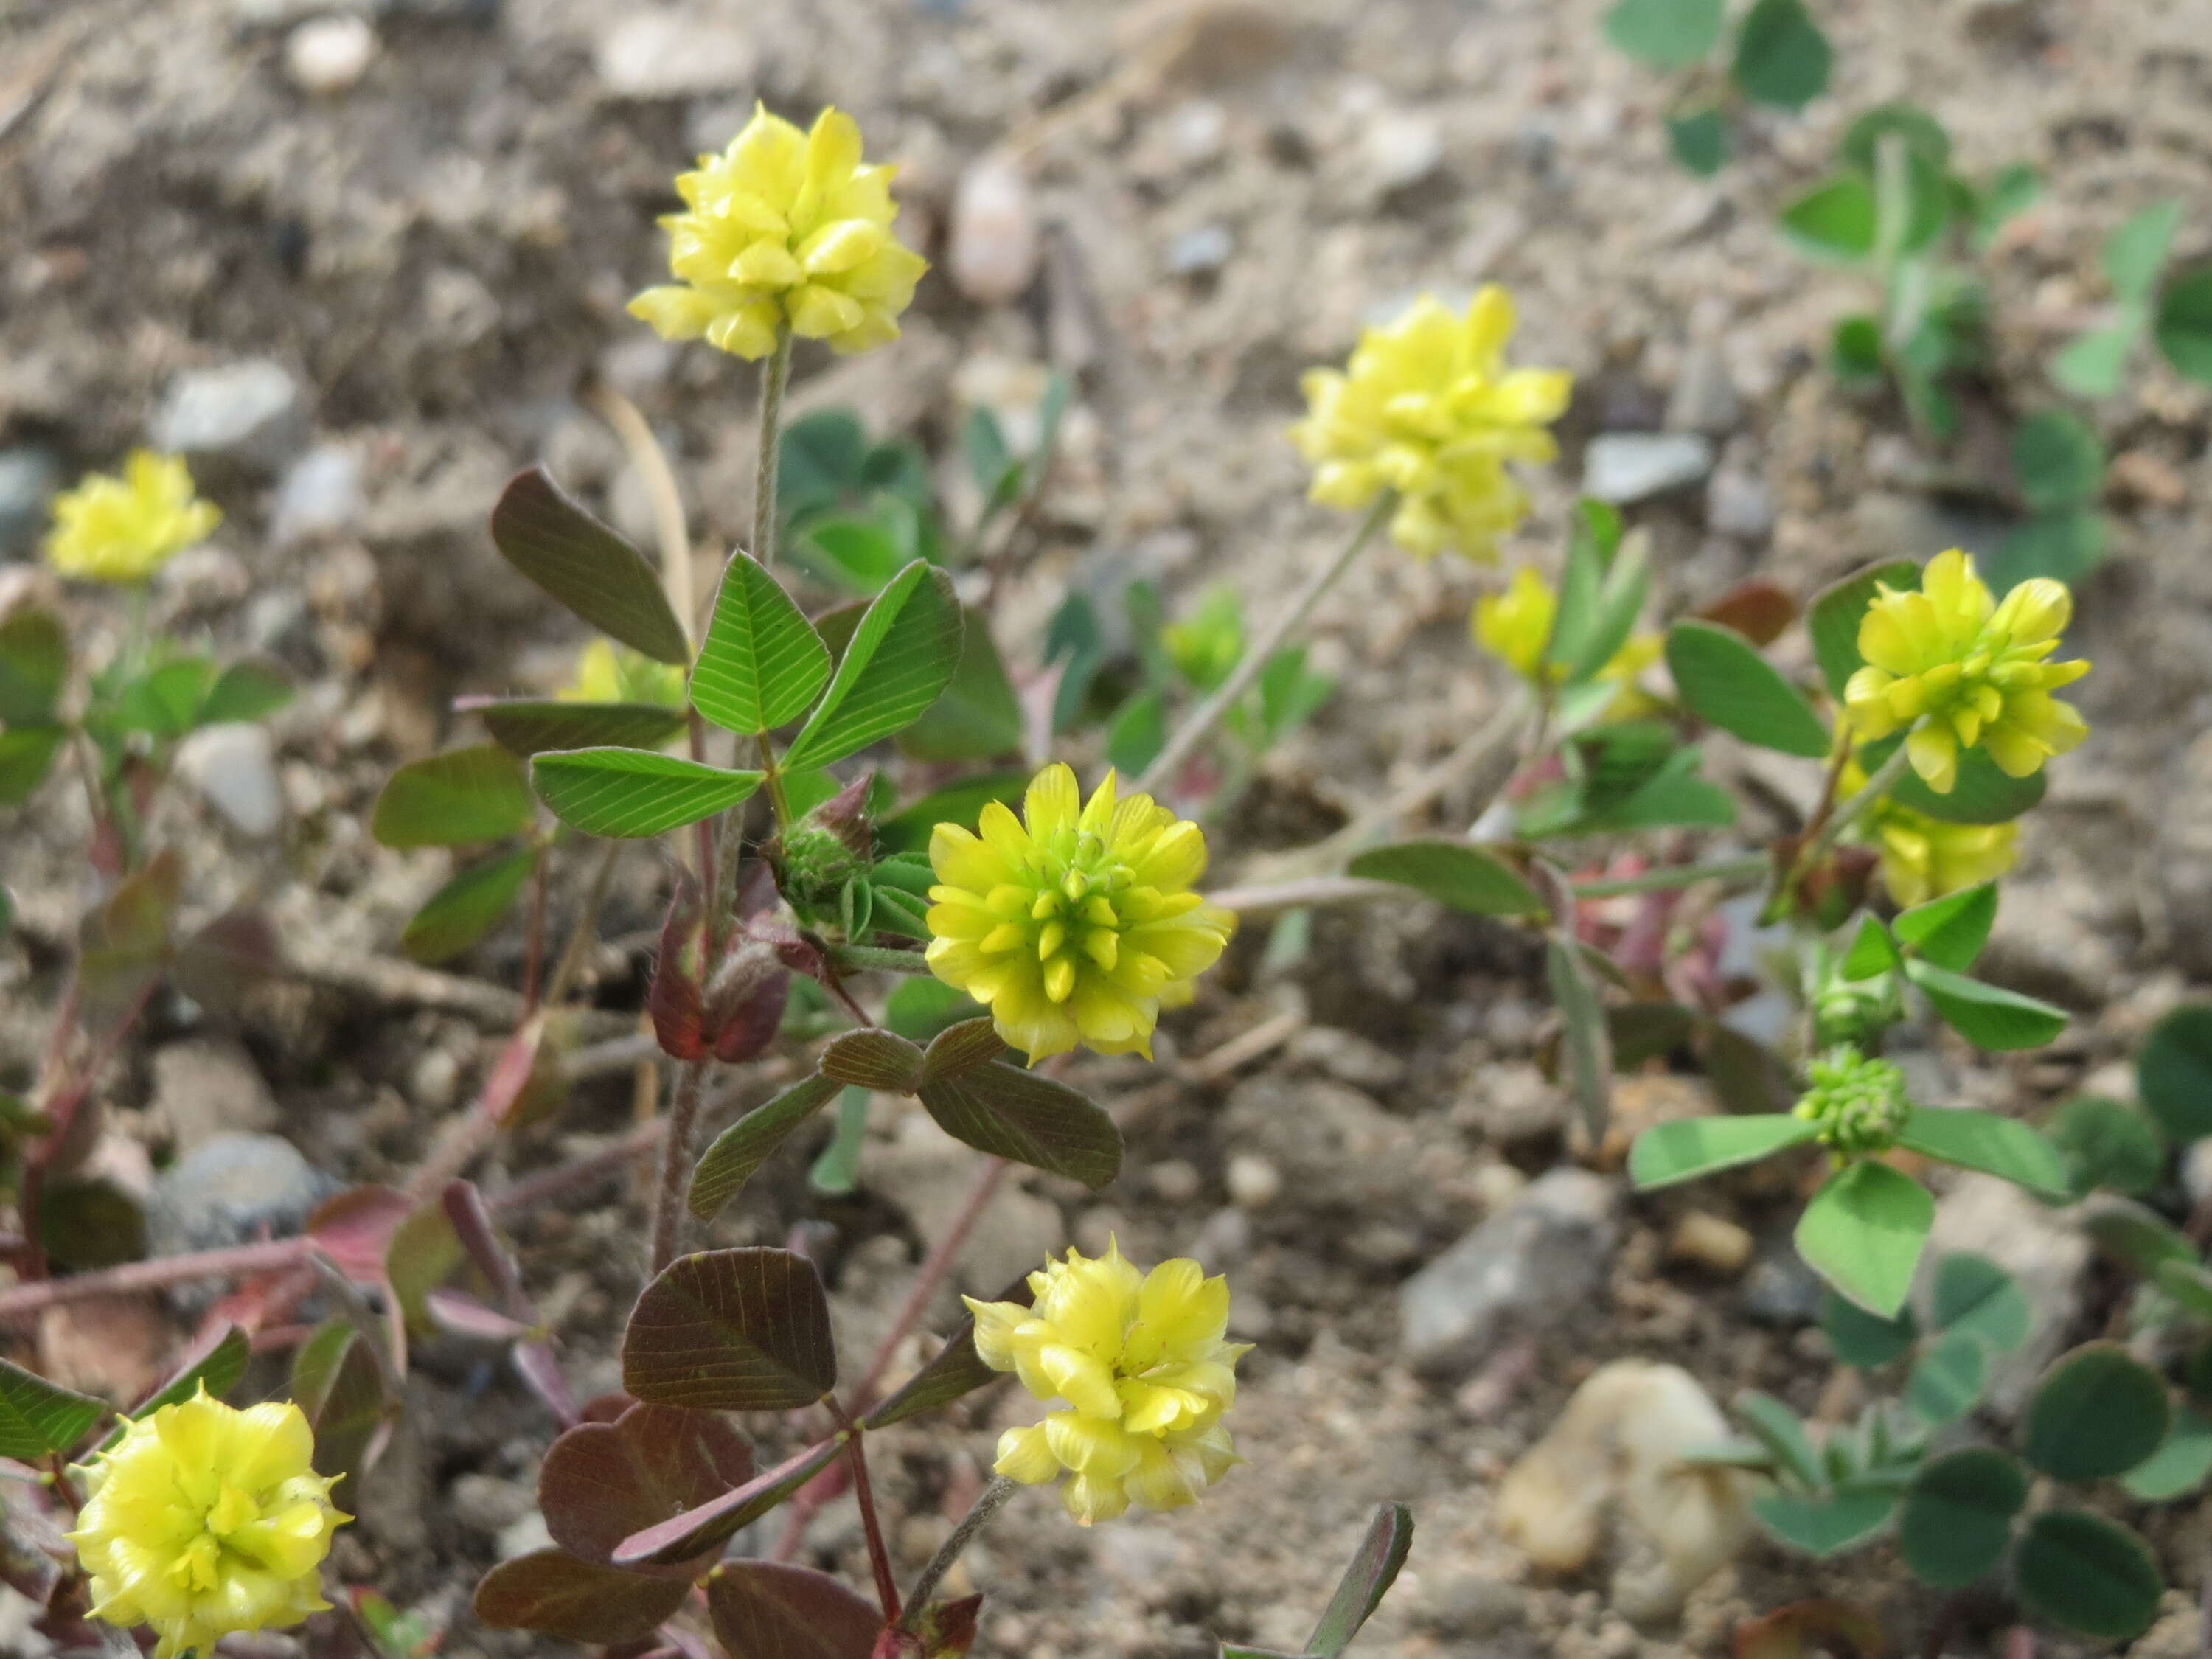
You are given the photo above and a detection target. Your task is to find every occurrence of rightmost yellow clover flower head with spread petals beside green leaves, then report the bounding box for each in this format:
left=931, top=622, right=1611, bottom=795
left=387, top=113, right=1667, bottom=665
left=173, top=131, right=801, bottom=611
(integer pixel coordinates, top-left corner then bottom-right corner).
left=1843, top=549, right=2088, bottom=794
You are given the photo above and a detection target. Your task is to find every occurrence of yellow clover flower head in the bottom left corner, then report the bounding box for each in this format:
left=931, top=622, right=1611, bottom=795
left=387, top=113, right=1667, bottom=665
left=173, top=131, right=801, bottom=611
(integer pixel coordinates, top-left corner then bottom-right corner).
left=69, top=1387, right=352, bottom=1659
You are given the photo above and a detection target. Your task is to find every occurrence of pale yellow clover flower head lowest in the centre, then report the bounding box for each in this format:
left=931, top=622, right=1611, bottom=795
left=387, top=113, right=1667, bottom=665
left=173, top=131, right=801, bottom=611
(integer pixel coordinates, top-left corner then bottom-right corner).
left=967, top=1243, right=1250, bottom=1526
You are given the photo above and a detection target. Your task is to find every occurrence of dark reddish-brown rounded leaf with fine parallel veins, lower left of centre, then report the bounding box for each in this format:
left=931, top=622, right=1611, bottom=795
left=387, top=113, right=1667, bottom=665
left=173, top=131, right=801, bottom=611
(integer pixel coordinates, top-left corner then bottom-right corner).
left=622, top=1250, right=836, bottom=1411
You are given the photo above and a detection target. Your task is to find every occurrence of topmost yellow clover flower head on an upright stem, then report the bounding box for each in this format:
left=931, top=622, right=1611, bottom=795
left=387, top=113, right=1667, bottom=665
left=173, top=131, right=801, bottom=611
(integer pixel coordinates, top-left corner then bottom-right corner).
left=630, top=104, right=929, bottom=358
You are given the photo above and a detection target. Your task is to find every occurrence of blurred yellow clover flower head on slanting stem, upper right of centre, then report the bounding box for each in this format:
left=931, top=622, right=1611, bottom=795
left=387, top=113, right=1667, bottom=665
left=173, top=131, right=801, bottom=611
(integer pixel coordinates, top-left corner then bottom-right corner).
left=1290, top=283, right=1575, bottom=560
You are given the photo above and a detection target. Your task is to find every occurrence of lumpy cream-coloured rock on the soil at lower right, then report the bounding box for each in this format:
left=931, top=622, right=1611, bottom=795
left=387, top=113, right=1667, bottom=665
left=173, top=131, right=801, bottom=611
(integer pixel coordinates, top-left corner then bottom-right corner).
left=1498, top=1360, right=1752, bottom=1621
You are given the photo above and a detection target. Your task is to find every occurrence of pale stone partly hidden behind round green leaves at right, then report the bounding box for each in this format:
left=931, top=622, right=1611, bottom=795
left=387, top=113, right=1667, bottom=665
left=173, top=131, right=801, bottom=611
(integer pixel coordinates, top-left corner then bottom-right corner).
left=1913, top=1175, right=2090, bottom=1418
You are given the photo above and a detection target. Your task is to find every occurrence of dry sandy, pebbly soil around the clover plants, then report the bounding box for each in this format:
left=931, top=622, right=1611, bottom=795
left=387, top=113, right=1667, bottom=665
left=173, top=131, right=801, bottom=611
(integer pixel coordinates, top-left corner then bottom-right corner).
left=0, top=0, right=2212, bottom=1659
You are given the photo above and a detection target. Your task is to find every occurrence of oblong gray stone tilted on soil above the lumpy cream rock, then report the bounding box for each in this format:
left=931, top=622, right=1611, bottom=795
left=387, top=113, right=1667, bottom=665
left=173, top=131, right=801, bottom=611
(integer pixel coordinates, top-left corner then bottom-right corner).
left=1398, top=1168, right=1619, bottom=1369
